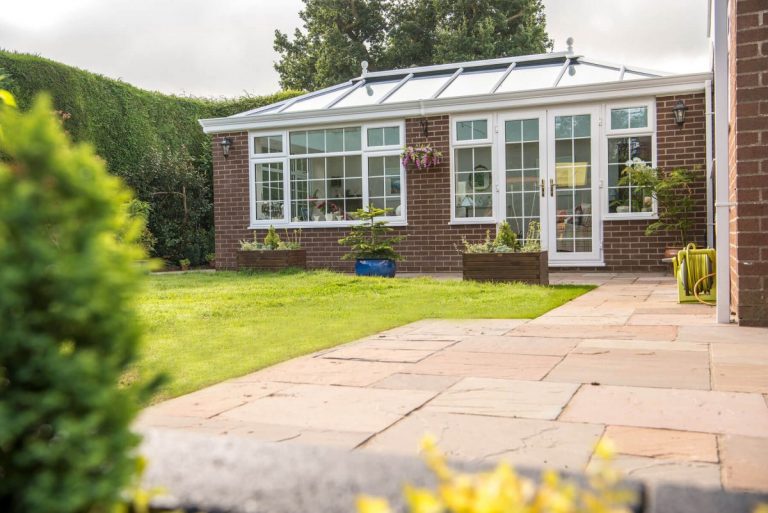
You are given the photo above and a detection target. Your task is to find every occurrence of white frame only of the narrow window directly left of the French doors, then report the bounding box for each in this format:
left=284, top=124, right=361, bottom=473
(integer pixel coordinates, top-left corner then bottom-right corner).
left=448, top=113, right=499, bottom=225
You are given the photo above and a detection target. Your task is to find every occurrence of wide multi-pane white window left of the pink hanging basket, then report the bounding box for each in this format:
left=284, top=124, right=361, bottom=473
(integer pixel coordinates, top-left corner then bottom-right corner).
left=249, top=122, right=406, bottom=228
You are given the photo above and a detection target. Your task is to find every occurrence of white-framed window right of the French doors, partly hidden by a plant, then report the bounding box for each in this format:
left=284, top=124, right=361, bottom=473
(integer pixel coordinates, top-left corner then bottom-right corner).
left=603, top=100, right=657, bottom=219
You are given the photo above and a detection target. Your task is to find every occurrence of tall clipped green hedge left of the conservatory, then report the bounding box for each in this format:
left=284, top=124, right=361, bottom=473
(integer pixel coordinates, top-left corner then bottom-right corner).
left=0, top=51, right=298, bottom=263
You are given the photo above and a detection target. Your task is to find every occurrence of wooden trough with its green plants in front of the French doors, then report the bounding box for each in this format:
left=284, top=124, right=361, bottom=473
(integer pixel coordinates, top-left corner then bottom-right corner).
left=461, top=221, right=549, bottom=285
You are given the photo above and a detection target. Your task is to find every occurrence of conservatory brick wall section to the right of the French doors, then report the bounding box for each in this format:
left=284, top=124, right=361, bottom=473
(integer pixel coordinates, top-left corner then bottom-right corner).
left=603, top=93, right=707, bottom=272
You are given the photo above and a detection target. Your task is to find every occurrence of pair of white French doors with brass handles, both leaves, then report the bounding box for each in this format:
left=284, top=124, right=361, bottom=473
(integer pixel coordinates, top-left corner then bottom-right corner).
left=495, top=107, right=602, bottom=266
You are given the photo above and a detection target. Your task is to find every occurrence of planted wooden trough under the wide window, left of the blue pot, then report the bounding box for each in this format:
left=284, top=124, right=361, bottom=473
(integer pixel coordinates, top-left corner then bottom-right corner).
left=237, top=226, right=307, bottom=271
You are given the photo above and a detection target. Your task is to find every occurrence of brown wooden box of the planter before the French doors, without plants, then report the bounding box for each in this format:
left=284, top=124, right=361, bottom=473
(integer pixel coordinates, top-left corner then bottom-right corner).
left=462, top=251, right=549, bottom=285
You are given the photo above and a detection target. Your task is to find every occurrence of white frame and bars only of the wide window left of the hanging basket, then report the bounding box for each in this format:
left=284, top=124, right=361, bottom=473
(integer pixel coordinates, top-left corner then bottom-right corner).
left=248, top=119, right=408, bottom=230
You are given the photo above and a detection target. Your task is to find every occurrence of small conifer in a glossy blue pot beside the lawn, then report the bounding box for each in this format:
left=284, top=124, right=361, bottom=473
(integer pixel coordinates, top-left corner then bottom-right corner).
left=339, top=205, right=405, bottom=278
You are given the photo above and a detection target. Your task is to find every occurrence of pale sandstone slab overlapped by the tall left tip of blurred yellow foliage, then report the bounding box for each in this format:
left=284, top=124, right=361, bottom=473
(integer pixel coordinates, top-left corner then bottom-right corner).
left=362, top=410, right=603, bottom=471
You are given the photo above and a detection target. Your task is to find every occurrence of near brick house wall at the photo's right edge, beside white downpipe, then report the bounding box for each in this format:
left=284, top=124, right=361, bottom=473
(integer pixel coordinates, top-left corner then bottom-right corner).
left=728, top=0, right=768, bottom=326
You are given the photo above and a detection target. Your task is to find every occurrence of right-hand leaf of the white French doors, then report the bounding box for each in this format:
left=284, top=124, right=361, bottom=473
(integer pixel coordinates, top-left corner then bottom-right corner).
left=546, top=107, right=601, bottom=265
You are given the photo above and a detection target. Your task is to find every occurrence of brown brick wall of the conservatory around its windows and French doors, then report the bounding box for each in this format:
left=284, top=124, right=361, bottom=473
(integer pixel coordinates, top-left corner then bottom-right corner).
left=213, top=93, right=706, bottom=272
